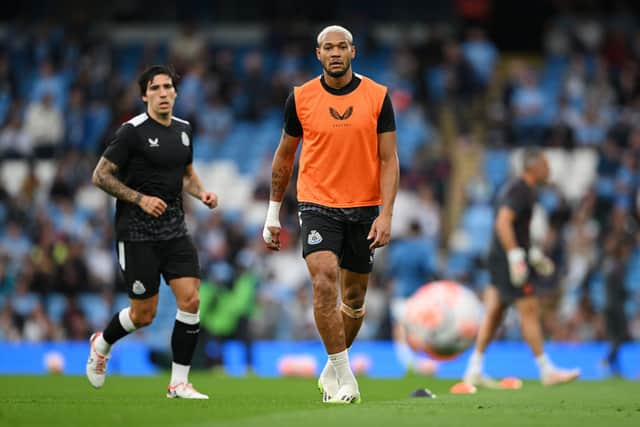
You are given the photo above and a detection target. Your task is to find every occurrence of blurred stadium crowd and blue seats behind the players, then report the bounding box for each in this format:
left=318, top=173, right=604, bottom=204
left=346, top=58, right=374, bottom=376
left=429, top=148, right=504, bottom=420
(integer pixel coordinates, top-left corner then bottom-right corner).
left=0, top=8, right=640, bottom=362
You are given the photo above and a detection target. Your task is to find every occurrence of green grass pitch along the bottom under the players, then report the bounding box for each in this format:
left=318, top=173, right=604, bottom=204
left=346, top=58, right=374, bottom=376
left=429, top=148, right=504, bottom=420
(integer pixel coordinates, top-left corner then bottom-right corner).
left=0, top=373, right=640, bottom=427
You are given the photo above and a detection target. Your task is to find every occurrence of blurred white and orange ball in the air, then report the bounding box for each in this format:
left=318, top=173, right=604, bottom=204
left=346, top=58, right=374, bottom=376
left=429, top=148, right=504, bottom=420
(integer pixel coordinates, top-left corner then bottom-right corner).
left=403, top=281, right=483, bottom=360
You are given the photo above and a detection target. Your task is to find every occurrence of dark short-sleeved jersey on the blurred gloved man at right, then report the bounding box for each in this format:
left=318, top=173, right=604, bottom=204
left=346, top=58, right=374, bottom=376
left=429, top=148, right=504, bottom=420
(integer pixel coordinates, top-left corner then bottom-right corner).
left=491, top=178, right=538, bottom=252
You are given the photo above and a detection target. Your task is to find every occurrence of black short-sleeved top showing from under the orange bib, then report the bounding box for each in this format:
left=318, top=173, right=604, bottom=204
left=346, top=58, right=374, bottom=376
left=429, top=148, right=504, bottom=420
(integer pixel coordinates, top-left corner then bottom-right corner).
left=284, top=74, right=396, bottom=222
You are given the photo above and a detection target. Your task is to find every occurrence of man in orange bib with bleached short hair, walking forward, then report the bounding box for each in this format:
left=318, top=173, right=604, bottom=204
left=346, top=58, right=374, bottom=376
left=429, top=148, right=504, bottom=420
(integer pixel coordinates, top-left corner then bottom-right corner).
left=262, top=25, right=399, bottom=403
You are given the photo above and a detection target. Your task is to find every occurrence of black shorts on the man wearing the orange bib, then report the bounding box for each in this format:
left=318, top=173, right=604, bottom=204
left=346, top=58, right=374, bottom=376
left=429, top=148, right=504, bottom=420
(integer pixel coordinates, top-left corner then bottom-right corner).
left=300, top=211, right=373, bottom=274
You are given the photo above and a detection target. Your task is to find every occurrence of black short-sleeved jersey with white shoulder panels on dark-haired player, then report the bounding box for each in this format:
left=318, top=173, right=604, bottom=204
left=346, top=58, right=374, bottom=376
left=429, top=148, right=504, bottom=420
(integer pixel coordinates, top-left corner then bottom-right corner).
left=103, top=113, right=193, bottom=241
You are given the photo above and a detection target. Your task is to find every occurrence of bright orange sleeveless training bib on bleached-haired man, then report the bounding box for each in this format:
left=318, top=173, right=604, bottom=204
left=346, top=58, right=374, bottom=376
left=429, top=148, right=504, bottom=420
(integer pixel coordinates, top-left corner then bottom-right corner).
left=285, top=75, right=395, bottom=208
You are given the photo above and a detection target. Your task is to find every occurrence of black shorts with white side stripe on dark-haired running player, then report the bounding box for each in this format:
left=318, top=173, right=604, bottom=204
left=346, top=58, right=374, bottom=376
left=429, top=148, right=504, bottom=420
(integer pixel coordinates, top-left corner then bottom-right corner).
left=116, top=236, right=200, bottom=299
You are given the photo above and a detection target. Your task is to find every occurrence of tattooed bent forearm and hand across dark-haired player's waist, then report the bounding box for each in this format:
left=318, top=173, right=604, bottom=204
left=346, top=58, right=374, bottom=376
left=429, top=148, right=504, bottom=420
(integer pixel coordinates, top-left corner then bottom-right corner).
left=91, top=157, right=167, bottom=217
